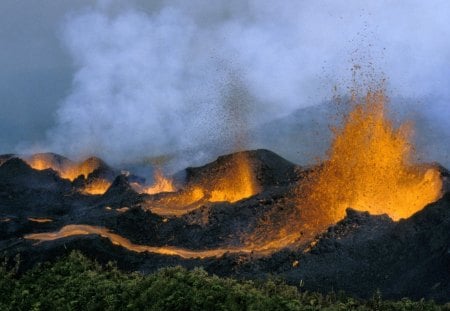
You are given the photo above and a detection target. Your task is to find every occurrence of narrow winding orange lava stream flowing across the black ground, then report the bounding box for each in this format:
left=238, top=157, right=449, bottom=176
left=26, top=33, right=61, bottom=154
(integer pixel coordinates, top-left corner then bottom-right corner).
left=24, top=225, right=298, bottom=259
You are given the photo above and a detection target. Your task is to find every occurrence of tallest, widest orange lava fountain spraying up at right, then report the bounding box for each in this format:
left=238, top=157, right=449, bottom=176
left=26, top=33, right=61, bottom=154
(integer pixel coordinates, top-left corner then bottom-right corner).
left=298, top=91, right=442, bottom=232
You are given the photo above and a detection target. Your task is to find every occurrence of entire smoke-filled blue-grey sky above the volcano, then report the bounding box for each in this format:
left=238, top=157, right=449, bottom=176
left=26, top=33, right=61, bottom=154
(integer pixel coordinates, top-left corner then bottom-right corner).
left=0, top=0, right=450, bottom=169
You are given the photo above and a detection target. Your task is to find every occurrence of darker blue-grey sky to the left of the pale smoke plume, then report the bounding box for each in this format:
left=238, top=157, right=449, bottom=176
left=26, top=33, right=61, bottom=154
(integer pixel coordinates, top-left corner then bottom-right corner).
left=0, top=0, right=155, bottom=153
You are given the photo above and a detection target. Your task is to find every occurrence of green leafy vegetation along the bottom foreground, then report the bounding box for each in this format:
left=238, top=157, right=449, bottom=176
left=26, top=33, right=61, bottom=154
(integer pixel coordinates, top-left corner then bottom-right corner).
left=0, top=252, right=450, bottom=310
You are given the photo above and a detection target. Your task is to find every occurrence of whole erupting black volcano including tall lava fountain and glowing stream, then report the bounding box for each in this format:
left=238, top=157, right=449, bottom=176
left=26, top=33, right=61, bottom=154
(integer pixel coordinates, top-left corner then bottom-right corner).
left=0, top=87, right=449, bottom=302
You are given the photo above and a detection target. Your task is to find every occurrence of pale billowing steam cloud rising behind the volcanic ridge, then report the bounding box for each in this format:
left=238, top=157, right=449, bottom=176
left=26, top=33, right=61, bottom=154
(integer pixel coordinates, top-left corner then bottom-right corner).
left=44, top=0, right=450, bottom=171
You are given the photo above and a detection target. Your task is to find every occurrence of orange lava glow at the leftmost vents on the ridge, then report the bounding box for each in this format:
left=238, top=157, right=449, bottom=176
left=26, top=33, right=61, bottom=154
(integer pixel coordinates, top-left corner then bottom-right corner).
left=25, top=153, right=101, bottom=181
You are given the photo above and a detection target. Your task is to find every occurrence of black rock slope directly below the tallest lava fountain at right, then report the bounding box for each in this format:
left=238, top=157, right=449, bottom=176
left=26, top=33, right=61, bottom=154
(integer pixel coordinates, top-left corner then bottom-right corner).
left=270, top=193, right=450, bottom=301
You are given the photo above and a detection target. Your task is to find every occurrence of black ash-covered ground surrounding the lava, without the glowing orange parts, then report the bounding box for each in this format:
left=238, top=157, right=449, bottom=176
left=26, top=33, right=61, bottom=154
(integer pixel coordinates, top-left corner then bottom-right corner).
left=0, top=150, right=450, bottom=302
